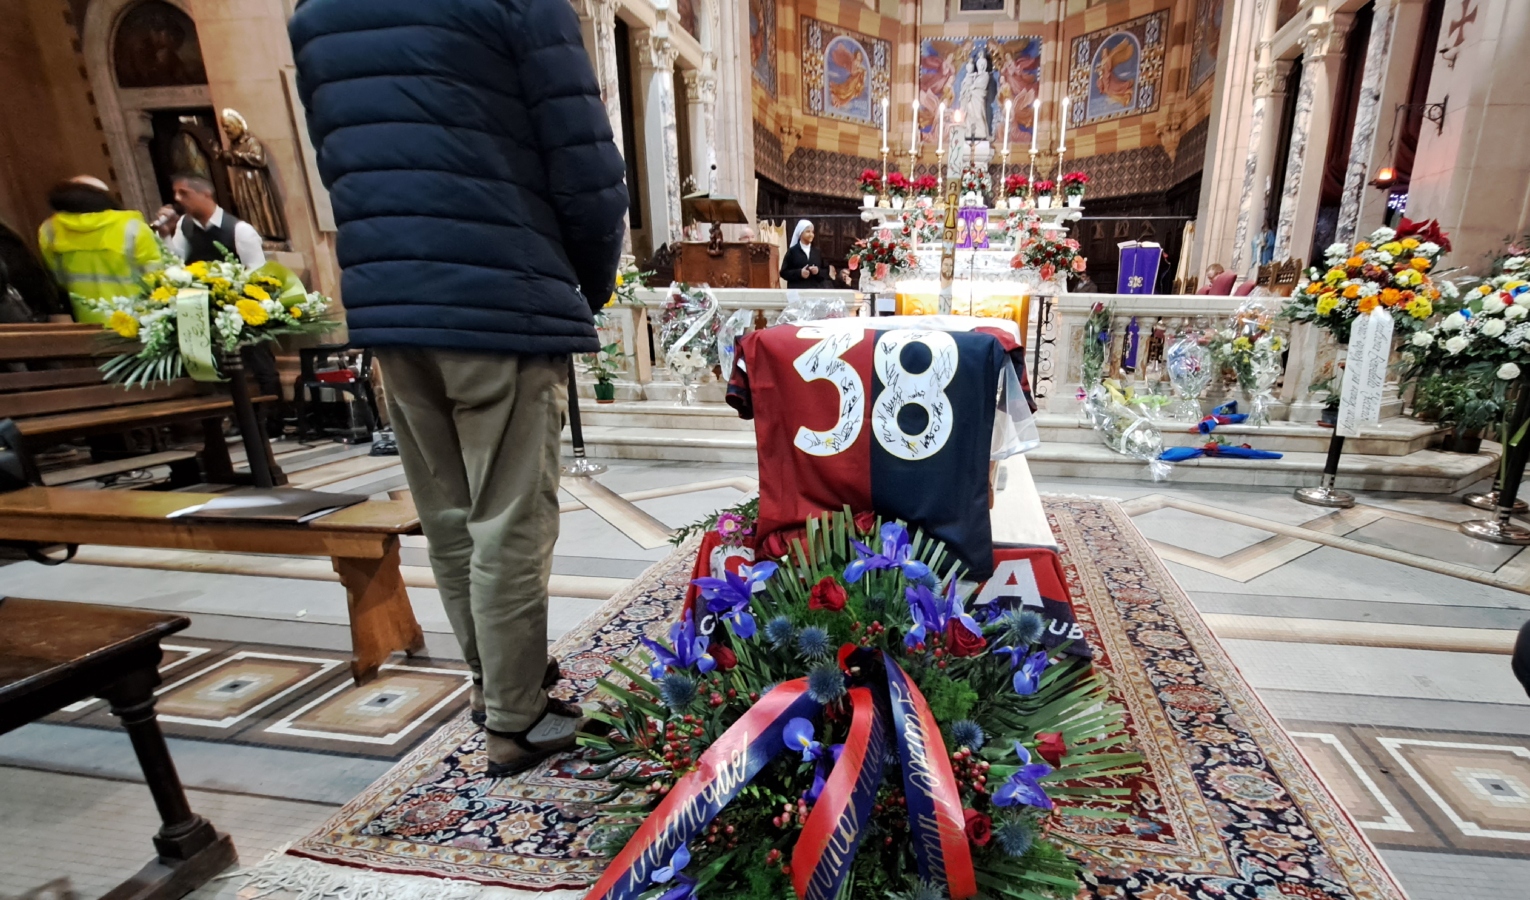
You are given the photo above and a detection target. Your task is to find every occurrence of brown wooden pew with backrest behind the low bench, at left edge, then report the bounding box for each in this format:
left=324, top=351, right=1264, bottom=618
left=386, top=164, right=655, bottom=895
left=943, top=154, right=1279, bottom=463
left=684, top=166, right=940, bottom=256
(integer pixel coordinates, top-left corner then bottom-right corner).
left=0, top=323, right=286, bottom=484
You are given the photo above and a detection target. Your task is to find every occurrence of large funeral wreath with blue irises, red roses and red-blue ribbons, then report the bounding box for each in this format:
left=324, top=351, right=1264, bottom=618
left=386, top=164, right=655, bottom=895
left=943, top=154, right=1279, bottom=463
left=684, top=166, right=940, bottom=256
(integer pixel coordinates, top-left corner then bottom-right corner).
left=580, top=511, right=1140, bottom=900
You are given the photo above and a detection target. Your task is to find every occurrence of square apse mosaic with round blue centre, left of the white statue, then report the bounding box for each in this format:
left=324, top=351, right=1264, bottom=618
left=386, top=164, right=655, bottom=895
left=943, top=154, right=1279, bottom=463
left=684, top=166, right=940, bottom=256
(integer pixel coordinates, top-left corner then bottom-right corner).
left=802, top=15, right=892, bottom=126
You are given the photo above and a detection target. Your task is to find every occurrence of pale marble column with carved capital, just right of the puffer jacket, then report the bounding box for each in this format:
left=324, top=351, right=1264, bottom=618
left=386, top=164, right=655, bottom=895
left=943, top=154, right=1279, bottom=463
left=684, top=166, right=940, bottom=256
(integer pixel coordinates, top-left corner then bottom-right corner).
left=633, top=29, right=681, bottom=249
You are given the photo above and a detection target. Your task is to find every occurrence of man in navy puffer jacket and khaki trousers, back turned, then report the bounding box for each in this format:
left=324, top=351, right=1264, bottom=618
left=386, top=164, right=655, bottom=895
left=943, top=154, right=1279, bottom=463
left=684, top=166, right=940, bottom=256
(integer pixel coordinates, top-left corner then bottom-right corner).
left=289, top=0, right=627, bottom=776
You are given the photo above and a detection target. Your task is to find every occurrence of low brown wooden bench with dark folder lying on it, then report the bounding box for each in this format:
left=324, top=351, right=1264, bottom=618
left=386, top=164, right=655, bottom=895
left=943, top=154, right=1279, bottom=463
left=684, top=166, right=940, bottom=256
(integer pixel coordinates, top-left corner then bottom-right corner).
left=0, top=487, right=425, bottom=684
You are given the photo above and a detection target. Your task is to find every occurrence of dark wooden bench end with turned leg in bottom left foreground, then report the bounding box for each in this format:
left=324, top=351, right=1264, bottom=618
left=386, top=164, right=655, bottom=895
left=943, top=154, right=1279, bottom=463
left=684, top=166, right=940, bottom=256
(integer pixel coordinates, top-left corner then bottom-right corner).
left=0, top=597, right=239, bottom=900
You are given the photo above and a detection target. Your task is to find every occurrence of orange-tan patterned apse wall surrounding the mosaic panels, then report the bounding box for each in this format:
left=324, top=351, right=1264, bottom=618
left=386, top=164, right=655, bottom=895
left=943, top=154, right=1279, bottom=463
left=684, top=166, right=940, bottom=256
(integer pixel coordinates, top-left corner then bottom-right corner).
left=754, top=0, right=1216, bottom=197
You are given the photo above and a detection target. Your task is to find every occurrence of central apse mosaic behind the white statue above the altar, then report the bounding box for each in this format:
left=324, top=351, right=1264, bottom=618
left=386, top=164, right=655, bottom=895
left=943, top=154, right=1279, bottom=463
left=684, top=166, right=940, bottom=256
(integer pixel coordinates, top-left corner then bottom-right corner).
left=920, top=35, right=1042, bottom=147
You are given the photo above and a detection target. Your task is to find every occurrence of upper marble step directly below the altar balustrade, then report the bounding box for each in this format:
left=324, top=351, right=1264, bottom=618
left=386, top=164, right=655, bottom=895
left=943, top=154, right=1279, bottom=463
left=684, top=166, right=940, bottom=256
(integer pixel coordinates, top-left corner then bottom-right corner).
left=580, top=401, right=1438, bottom=456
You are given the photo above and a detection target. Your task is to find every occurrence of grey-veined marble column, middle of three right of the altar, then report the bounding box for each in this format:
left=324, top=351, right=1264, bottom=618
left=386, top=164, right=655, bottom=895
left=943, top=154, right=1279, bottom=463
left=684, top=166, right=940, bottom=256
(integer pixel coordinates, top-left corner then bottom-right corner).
left=1273, top=11, right=1354, bottom=260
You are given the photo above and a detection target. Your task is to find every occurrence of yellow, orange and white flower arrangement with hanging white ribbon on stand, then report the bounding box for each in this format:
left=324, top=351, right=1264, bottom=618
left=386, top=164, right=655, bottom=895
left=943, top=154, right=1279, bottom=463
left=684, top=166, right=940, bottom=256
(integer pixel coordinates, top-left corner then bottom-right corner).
left=1281, top=219, right=1458, bottom=343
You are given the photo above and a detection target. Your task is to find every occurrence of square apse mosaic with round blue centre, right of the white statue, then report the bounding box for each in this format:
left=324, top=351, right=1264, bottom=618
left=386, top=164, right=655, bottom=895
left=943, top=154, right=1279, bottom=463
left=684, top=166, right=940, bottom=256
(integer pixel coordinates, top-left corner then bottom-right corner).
left=1068, top=9, right=1169, bottom=129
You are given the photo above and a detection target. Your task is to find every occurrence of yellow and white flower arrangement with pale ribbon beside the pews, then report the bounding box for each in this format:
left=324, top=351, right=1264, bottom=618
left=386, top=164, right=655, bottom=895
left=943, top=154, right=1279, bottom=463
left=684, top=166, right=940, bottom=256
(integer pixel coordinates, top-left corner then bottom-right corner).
left=89, top=254, right=337, bottom=386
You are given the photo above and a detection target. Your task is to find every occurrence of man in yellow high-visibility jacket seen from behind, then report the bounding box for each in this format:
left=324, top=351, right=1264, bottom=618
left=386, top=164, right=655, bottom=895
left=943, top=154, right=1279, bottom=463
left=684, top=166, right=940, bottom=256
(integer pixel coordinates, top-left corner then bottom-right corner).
left=37, top=174, right=162, bottom=321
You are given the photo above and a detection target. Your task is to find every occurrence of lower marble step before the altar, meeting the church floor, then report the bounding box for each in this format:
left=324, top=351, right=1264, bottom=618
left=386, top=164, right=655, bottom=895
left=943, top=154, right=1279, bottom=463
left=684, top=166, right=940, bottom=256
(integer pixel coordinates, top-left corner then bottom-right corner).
left=565, top=426, right=1498, bottom=493
